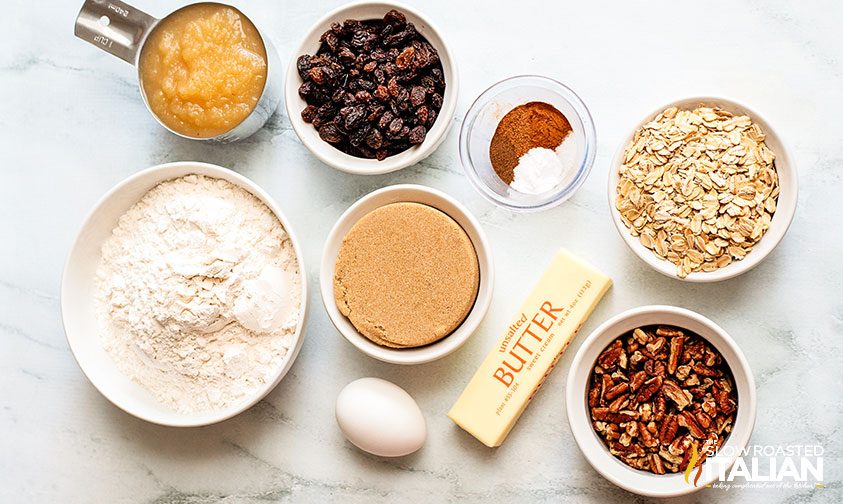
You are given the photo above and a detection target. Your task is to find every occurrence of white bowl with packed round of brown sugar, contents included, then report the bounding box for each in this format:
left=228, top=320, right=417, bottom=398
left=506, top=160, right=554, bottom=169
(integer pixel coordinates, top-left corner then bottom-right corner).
left=319, top=184, right=494, bottom=364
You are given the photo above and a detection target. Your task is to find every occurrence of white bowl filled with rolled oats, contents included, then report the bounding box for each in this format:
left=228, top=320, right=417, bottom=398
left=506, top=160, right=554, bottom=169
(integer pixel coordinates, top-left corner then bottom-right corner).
left=609, top=97, right=798, bottom=282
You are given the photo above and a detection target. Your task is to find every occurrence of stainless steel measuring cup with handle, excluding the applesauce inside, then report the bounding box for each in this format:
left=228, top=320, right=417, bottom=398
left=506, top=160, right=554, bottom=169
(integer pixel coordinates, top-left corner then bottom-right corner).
left=74, top=0, right=283, bottom=142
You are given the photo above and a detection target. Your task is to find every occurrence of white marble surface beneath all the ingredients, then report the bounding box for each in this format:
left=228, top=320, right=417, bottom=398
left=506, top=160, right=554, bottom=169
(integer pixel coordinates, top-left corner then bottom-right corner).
left=0, top=0, right=843, bottom=503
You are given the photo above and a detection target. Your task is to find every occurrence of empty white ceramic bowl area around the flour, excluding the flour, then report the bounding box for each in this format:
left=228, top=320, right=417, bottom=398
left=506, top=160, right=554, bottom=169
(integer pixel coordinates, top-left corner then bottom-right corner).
left=61, top=162, right=307, bottom=427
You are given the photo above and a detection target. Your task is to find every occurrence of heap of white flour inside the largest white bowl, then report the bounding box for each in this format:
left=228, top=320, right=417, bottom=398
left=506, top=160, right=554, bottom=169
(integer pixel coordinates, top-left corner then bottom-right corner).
left=95, top=175, right=302, bottom=413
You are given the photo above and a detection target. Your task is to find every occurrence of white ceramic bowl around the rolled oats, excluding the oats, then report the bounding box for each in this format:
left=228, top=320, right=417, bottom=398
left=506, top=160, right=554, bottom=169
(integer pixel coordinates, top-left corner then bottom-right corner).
left=608, top=96, right=799, bottom=282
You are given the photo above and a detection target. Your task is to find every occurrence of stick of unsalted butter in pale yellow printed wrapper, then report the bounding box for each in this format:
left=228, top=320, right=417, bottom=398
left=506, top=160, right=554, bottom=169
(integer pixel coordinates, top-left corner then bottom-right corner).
left=448, top=249, right=612, bottom=447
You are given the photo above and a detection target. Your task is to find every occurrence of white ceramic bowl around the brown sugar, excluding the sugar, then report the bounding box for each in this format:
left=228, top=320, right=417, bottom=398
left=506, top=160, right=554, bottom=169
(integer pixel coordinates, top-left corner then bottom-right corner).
left=319, top=184, right=495, bottom=364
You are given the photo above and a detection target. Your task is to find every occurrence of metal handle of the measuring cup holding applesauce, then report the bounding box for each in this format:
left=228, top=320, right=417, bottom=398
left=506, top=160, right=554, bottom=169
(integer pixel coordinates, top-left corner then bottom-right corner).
left=73, top=0, right=158, bottom=65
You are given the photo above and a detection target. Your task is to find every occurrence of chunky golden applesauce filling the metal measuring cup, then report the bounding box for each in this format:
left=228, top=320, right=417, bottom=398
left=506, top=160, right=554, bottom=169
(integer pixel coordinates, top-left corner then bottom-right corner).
left=138, top=3, right=267, bottom=138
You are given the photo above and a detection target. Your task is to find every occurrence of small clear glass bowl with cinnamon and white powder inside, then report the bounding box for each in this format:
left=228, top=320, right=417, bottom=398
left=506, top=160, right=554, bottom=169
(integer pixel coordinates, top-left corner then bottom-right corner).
left=460, top=75, right=596, bottom=211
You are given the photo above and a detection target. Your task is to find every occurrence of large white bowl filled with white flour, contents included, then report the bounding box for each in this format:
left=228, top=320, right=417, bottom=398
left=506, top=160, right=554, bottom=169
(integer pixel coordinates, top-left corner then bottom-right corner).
left=61, top=162, right=307, bottom=427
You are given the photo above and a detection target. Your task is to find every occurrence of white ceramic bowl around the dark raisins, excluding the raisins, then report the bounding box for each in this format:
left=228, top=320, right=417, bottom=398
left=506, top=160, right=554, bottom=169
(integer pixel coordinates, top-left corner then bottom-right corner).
left=284, top=2, right=459, bottom=175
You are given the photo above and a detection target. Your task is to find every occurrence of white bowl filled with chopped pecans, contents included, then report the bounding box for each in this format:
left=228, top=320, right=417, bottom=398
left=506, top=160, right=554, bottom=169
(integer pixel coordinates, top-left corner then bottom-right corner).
left=566, top=306, right=756, bottom=497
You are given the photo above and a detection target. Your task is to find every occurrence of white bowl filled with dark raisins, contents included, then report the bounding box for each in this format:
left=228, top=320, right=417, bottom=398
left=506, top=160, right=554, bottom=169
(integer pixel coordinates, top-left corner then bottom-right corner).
left=285, top=2, right=458, bottom=175
